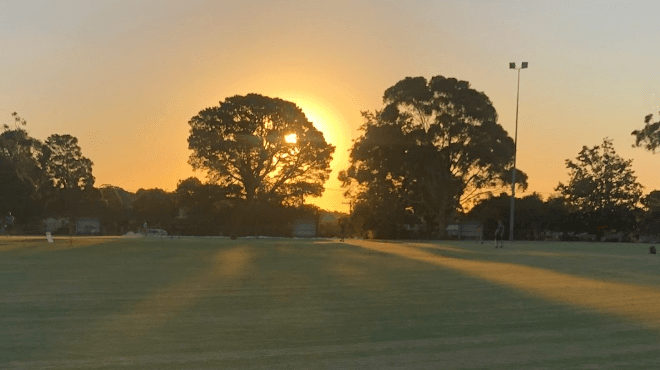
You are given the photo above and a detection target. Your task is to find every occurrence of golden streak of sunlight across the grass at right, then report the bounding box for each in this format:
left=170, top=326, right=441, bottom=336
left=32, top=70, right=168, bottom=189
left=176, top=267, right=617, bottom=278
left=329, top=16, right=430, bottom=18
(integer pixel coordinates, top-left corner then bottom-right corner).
left=348, top=240, right=660, bottom=329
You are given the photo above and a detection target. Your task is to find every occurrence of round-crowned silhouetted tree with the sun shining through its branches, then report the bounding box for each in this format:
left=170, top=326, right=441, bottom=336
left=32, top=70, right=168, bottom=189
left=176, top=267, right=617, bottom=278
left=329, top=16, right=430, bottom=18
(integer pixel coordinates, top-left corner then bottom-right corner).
left=188, top=94, right=334, bottom=204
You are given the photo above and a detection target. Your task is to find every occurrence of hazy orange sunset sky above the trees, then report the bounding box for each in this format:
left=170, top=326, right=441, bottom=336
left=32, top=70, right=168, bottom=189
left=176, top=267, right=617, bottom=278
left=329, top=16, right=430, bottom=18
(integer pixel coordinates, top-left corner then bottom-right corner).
left=0, top=0, right=660, bottom=210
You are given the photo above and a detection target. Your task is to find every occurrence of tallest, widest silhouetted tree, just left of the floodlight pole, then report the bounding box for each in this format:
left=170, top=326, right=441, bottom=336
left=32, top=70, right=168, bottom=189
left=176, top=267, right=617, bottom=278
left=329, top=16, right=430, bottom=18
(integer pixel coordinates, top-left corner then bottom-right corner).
left=340, top=76, right=527, bottom=235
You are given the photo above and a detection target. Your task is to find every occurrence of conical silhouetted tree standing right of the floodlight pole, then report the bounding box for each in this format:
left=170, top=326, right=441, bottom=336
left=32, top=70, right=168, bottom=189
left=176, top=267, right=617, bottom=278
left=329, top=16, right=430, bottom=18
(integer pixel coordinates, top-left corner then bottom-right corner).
left=555, top=138, right=642, bottom=234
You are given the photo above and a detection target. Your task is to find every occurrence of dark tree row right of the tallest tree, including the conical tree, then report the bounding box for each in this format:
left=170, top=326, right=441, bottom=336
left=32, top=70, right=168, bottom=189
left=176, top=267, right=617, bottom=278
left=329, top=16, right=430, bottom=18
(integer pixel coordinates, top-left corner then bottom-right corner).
left=466, top=138, right=660, bottom=239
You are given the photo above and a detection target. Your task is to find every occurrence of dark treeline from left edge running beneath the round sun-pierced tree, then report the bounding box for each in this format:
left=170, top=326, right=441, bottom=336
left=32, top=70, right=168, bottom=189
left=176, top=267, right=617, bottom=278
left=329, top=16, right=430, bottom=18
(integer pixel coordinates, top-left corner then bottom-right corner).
left=0, top=113, right=319, bottom=236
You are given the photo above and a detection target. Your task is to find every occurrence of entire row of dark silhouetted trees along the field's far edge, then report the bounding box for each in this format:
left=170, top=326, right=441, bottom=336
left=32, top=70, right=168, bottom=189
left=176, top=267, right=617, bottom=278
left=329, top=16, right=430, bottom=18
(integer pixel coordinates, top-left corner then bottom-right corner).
left=0, top=76, right=660, bottom=238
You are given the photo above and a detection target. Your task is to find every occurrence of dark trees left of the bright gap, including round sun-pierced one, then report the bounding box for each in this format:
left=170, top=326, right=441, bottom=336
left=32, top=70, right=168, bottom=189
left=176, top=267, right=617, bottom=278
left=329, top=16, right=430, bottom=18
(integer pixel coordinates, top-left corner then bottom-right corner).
left=0, top=94, right=334, bottom=236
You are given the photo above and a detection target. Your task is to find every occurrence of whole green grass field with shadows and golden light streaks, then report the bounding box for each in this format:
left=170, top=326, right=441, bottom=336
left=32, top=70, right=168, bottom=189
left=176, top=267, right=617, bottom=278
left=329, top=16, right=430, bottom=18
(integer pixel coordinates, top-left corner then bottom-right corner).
left=0, top=237, right=660, bottom=369
